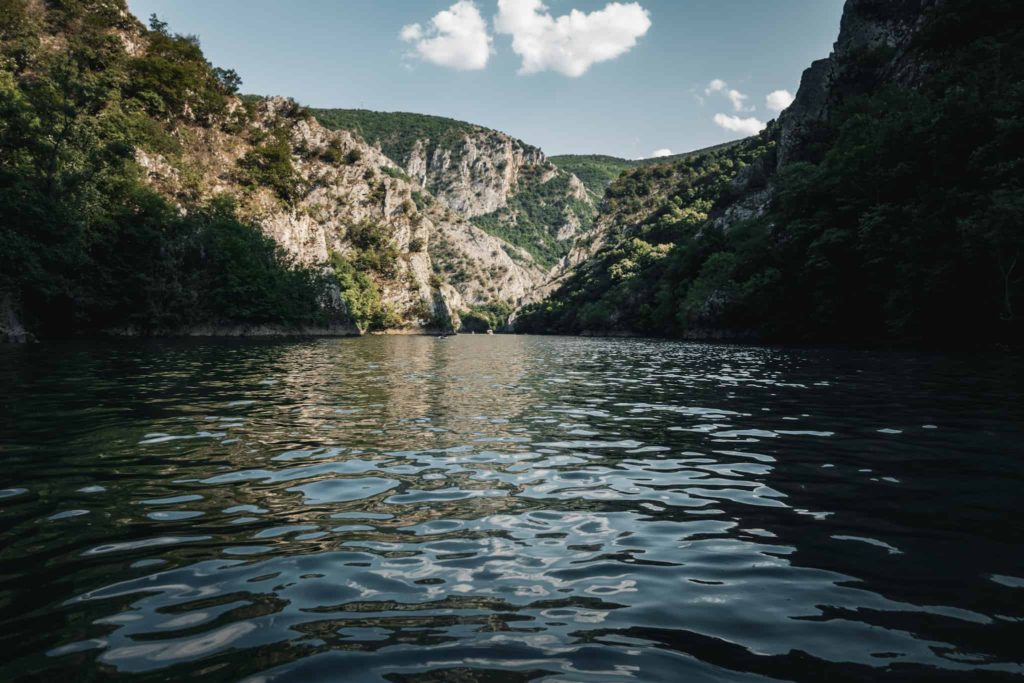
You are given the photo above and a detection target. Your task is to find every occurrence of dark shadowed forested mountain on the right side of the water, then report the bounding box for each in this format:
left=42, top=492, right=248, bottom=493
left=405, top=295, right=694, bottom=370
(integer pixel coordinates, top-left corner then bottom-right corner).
left=517, top=0, right=1024, bottom=345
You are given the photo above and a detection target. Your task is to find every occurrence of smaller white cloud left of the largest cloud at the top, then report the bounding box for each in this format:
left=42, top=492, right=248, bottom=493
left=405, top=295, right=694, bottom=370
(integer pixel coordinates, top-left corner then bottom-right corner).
left=400, top=0, right=493, bottom=71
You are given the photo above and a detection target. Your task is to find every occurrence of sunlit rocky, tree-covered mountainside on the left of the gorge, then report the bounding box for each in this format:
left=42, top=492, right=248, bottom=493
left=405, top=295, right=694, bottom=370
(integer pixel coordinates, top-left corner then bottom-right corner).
left=0, top=0, right=557, bottom=338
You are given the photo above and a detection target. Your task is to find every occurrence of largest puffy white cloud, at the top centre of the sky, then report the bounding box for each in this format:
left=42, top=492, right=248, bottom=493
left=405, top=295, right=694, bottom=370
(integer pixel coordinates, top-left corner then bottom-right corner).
left=495, top=0, right=651, bottom=78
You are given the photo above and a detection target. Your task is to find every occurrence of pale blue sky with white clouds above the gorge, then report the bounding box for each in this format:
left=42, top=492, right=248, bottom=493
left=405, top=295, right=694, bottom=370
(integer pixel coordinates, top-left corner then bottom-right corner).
left=123, top=0, right=843, bottom=159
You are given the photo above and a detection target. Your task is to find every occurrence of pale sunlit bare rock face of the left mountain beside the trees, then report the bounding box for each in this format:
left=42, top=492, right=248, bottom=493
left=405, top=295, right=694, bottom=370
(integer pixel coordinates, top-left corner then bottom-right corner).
left=137, top=98, right=547, bottom=328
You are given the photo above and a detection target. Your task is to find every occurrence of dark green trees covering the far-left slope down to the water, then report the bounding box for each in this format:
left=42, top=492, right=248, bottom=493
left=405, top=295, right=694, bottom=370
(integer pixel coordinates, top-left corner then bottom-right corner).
left=0, top=0, right=338, bottom=335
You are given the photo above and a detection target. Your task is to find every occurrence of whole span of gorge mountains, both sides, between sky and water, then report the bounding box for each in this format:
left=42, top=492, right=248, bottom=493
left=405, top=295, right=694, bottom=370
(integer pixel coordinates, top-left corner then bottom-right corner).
left=6, top=0, right=1024, bottom=345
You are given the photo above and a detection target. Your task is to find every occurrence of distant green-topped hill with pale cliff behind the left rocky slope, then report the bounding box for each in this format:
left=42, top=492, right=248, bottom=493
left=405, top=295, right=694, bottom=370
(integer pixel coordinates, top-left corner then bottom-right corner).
left=313, top=110, right=596, bottom=268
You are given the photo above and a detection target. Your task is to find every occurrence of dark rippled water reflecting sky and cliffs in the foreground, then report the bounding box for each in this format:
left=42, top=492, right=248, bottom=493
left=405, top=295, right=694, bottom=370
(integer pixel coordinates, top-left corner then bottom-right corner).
left=0, top=336, right=1024, bottom=682
